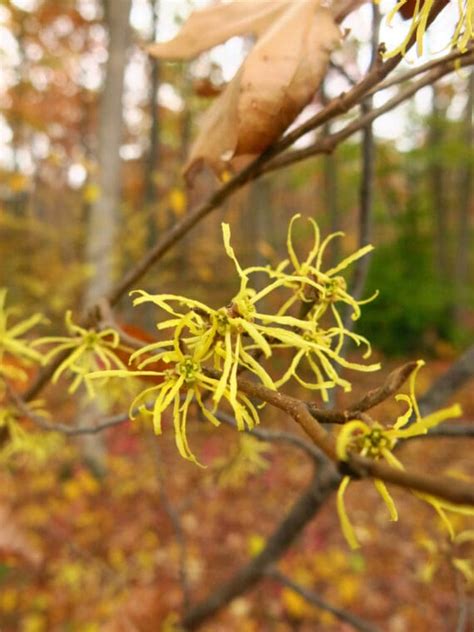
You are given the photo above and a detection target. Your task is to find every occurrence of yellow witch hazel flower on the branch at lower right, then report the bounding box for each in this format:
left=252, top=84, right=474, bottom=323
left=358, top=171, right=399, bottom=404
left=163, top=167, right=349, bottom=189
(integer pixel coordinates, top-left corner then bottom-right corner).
left=336, top=360, right=474, bottom=548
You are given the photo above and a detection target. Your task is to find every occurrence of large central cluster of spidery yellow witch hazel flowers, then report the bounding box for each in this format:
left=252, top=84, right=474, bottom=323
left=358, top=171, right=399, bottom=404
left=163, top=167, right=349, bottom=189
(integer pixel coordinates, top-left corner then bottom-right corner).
left=87, top=216, right=380, bottom=462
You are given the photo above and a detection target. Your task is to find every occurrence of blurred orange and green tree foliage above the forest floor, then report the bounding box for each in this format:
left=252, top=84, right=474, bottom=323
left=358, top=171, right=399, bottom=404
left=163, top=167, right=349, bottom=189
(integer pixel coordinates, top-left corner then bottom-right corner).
left=0, top=0, right=474, bottom=355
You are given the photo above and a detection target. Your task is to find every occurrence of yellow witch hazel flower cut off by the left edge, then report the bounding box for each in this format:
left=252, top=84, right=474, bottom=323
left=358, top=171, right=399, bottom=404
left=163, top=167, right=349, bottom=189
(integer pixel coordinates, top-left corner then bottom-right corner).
left=0, top=288, right=45, bottom=380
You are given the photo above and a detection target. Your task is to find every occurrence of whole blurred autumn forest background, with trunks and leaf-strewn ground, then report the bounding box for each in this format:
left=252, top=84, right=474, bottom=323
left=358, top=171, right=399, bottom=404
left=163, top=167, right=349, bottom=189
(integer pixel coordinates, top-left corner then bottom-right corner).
left=0, top=0, right=474, bottom=632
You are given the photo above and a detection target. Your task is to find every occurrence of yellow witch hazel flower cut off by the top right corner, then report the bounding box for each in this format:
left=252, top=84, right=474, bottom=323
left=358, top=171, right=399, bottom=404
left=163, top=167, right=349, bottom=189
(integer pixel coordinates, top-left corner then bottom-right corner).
left=385, top=0, right=474, bottom=58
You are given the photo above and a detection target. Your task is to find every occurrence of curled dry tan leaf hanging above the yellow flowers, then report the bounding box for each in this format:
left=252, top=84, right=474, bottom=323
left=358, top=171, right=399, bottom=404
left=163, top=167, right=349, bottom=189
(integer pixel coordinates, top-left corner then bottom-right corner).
left=149, top=0, right=341, bottom=181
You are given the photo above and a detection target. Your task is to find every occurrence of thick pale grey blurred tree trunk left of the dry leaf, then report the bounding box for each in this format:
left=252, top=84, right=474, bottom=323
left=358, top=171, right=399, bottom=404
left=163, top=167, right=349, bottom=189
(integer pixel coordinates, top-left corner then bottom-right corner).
left=79, top=0, right=131, bottom=472
